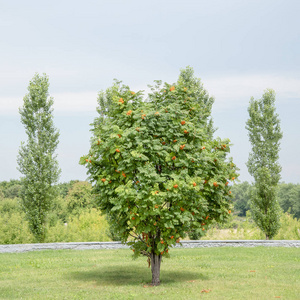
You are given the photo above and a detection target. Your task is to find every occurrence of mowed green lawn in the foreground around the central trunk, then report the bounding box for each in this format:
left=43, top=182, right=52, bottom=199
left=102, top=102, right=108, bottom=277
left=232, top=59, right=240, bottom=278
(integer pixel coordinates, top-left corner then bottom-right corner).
left=0, top=247, right=300, bottom=299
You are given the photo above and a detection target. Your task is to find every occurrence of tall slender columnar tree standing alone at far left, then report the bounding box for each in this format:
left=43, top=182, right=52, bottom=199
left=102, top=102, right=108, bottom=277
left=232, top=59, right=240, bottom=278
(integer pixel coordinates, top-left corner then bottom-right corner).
left=18, top=74, right=60, bottom=242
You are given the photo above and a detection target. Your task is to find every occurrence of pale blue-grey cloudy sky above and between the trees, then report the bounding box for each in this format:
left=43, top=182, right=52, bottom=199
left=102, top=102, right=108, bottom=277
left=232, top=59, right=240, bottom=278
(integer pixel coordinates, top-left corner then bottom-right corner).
left=0, top=0, right=300, bottom=183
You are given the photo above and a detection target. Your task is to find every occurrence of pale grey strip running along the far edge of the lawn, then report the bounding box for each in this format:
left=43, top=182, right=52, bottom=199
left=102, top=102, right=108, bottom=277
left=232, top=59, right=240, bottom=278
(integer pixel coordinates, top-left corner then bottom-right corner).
left=0, top=240, right=300, bottom=253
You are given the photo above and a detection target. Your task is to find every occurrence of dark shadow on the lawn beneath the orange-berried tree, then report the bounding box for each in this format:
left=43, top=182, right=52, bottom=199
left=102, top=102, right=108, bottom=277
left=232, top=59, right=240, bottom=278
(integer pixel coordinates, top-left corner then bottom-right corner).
left=68, top=265, right=208, bottom=286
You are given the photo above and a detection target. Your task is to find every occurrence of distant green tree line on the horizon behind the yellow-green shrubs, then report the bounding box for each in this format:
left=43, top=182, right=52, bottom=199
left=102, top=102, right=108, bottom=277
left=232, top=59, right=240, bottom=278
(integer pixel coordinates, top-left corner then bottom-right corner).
left=0, top=179, right=300, bottom=221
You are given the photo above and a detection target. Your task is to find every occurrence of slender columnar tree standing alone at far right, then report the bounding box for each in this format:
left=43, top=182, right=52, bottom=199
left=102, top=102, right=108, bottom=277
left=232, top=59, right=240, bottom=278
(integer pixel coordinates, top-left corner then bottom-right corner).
left=246, top=90, right=282, bottom=239
